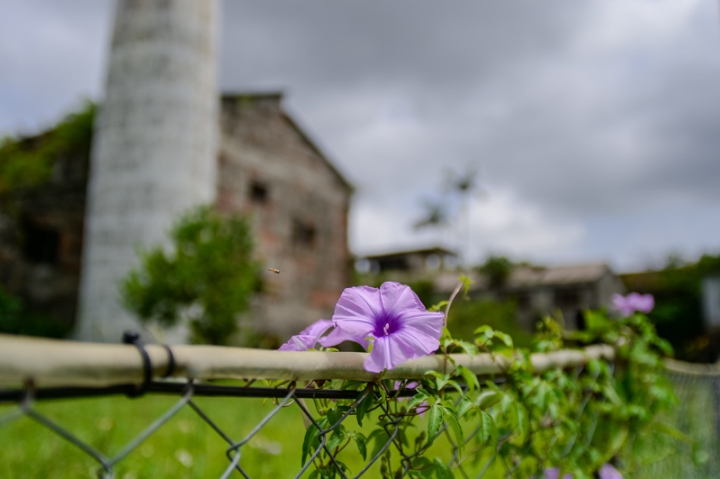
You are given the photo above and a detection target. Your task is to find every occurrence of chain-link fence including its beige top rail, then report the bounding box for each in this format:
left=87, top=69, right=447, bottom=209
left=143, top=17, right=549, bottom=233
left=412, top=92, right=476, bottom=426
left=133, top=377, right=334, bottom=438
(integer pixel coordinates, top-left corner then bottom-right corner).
left=0, top=337, right=718, bottom=479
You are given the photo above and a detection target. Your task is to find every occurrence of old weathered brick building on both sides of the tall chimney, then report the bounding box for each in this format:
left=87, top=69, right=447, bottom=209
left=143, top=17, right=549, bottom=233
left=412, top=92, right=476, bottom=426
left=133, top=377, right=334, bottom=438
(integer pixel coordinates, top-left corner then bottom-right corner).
left=0, top=93, right=352, bottom=341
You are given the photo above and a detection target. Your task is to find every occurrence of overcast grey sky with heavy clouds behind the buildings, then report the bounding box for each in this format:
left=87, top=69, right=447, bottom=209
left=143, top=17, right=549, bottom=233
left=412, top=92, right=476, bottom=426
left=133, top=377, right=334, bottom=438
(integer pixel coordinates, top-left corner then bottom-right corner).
left=0, top=0, right=720, bottom=271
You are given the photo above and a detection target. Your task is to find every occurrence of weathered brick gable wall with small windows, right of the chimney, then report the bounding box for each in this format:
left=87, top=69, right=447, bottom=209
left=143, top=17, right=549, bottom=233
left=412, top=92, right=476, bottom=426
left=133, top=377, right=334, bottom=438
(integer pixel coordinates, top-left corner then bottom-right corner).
left=218, top=95, right=351, bottom=337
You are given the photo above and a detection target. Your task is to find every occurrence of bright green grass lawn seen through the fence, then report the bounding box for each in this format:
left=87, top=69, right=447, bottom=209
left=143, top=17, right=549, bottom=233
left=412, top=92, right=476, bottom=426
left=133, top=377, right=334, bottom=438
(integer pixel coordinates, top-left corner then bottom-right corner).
left=0, top=395, right=506, bottom=479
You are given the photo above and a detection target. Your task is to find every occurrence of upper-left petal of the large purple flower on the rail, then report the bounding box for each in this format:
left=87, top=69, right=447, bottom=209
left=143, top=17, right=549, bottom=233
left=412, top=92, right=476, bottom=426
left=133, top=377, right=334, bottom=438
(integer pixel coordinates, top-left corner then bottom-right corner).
left=333, top=286, right=383, bottom=338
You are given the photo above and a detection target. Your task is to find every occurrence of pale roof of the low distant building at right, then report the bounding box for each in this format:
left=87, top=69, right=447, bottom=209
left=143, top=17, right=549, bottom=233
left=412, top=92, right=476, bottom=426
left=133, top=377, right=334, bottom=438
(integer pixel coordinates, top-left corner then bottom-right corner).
left=505, top=263, right=610, bottom=289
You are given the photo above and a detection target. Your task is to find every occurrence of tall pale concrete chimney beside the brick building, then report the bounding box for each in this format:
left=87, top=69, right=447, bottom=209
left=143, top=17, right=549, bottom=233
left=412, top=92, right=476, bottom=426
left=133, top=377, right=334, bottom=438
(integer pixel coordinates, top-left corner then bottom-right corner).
left=76, top=0, right=218, bottom=342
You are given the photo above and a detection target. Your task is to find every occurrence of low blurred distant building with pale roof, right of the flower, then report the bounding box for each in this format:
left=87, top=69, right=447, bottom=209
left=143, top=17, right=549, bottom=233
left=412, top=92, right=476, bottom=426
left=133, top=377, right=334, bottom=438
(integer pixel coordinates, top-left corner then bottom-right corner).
left=435, top=264, right=625, bottom=330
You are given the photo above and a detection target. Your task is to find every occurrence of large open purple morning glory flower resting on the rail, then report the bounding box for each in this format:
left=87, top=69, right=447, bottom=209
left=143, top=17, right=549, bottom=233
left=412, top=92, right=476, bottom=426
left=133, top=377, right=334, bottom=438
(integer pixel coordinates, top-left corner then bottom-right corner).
left=333, top=282, right=443, bottom=373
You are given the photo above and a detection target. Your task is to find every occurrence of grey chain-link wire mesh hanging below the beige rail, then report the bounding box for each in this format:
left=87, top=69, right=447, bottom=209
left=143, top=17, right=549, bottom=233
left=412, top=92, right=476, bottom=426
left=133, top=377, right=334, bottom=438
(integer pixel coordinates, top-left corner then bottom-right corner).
left=0, top=350, right=720, bottom=479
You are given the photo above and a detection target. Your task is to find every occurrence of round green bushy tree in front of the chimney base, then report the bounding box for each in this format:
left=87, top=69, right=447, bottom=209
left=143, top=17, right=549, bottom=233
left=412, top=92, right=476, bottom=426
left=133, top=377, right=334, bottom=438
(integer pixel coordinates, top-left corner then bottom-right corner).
left=122, top=206, right=259, bottom=344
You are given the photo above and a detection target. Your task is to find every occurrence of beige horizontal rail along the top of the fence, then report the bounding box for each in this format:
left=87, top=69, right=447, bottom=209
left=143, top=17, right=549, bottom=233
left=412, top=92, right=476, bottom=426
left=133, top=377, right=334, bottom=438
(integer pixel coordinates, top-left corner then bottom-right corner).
left=0, top=334, right=614, bottom=387
